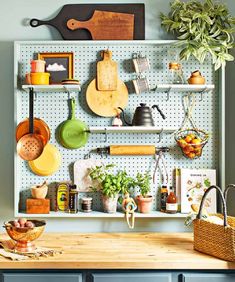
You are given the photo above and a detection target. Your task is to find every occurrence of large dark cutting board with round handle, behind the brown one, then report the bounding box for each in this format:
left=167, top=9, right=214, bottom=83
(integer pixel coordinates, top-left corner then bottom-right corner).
left=30, top=4, right=145, bottom=40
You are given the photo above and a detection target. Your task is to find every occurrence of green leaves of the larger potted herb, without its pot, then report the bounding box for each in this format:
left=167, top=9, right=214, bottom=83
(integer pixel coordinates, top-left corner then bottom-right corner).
left=89, top=164, right=134, bottom=198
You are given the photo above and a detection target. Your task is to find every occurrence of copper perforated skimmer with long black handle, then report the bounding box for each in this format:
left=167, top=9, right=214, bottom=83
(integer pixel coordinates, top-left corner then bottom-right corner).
left=16, top=89, right=44, bottom=161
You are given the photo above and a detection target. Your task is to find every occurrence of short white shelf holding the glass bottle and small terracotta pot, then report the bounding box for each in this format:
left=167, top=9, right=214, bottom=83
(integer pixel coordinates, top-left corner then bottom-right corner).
left=154, top=84, right=215, bottom=93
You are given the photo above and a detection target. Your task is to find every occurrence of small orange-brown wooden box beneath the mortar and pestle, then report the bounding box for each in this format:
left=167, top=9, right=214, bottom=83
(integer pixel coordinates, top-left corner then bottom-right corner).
left=26, top=199, right=50, bottom=214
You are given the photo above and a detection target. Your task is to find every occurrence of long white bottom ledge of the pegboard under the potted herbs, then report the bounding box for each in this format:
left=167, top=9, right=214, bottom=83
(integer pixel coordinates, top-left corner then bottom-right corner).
left=15, top=211, right=187, bottom=218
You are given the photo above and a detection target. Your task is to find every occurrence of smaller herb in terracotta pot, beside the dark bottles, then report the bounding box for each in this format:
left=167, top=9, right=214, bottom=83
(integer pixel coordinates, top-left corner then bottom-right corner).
left=135, top=171, right=153, bottom=213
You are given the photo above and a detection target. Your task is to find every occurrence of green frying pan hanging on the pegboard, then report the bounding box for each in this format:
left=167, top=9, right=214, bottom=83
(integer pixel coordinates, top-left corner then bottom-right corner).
left=58, top=98, right=89, bottom=149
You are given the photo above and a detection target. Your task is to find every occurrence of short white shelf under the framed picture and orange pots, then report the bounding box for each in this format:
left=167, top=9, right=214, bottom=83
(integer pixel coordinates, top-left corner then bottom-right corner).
left=22, top=84, right=81, bottom=93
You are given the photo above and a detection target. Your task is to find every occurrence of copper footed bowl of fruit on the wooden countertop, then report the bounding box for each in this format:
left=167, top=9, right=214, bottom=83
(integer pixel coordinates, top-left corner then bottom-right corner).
left=4, top=218, right=46, bottom=253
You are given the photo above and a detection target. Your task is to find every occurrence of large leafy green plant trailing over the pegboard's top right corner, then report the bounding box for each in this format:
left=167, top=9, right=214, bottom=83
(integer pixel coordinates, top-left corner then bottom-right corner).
left=160, top=0, right=235, bottom=70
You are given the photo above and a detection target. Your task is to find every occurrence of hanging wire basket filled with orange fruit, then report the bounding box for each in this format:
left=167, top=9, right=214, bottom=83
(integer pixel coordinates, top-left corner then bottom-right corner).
left=175, top=128, right=209, bottom=159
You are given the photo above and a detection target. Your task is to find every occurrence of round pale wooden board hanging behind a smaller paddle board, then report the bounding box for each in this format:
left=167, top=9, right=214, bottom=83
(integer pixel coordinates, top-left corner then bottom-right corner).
left=86, top=79, right=128, bottom=117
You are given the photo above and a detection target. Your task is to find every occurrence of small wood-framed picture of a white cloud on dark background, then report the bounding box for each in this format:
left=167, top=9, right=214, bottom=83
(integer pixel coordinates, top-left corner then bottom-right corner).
left=38, top=52, right=74, bottom=84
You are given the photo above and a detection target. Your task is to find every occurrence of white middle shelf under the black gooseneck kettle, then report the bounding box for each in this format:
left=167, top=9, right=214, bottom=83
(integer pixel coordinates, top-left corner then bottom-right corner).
left=89, top=126, right=177, bottom=133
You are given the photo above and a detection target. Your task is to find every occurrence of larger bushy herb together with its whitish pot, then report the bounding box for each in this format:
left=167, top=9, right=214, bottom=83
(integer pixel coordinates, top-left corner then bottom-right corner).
left=89, top=164, right=134, bottom=213
